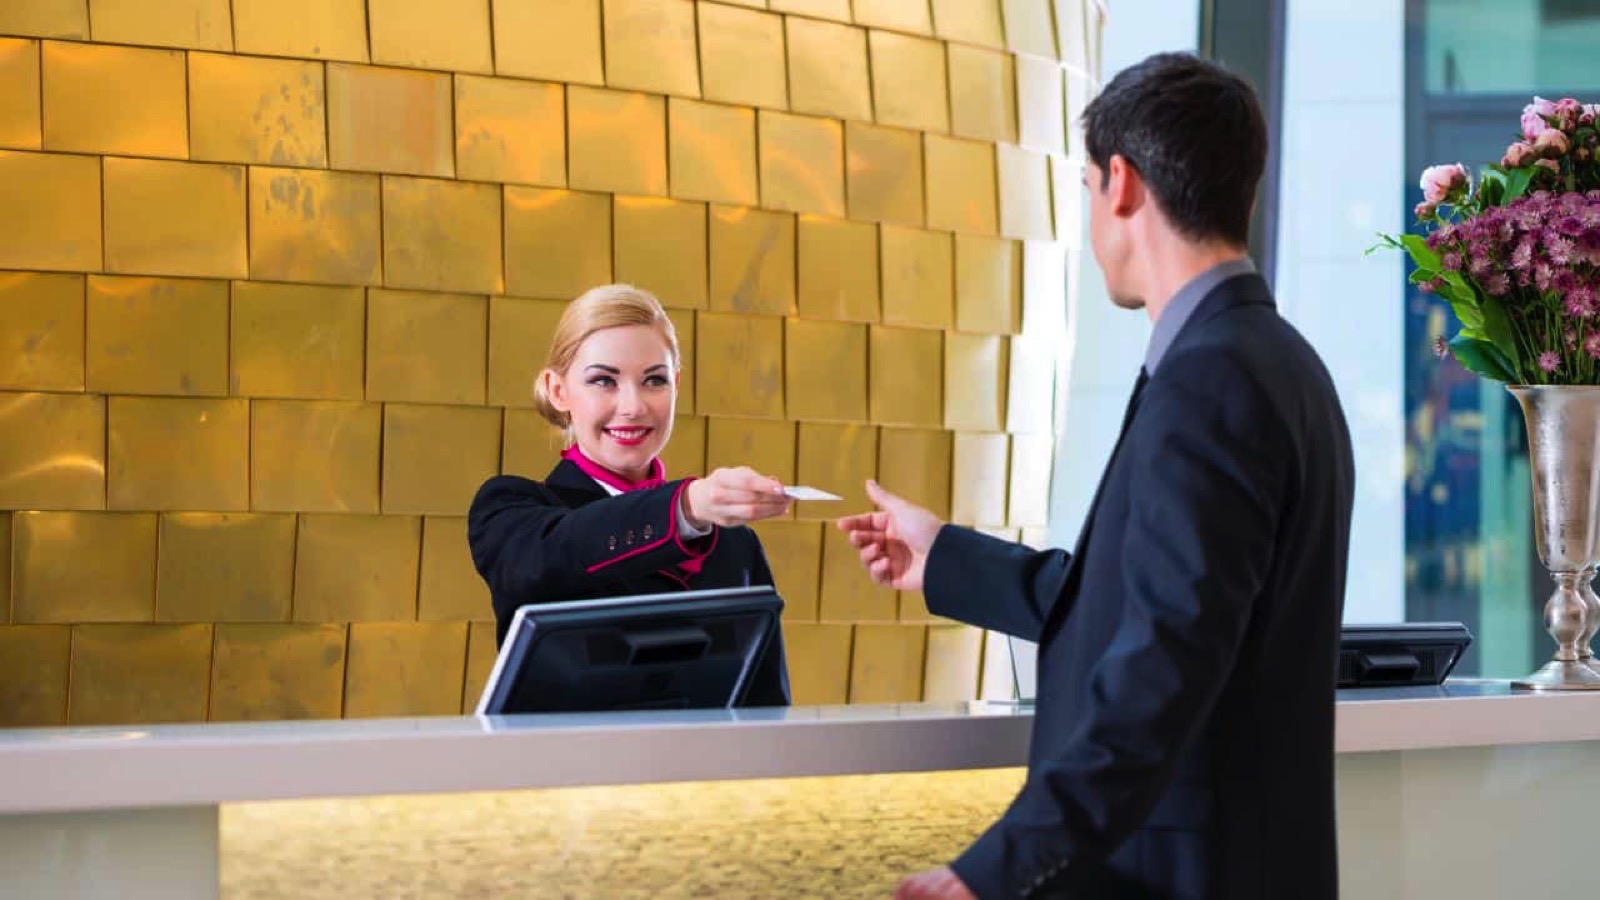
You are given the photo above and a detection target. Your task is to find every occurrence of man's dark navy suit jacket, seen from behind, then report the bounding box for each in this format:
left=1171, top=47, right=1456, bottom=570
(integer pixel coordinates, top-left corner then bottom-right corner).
left=926, top=274, right=1355, bottom=900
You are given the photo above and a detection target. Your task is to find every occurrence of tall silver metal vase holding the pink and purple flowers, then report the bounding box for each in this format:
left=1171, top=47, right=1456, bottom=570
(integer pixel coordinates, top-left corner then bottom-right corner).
left=1507, top=384, right=1600, bottom=690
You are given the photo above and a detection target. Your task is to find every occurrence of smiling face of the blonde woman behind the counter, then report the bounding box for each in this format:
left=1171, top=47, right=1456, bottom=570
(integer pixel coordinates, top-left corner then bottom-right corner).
left=539, top=325, right=678, bottom=480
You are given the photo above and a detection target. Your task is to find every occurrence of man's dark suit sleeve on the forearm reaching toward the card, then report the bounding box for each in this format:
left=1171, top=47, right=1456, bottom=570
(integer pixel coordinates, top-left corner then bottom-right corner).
left=923, top=525, right=1072, bottom=641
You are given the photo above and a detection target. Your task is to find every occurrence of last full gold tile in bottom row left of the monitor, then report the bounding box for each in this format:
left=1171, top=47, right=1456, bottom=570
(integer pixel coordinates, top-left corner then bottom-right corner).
left=344, top=621, right=467, bottom=719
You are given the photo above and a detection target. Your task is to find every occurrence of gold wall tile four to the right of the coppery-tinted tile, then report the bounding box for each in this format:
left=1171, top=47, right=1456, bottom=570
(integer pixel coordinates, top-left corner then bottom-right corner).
left=757, top=110, right=845, bottom=216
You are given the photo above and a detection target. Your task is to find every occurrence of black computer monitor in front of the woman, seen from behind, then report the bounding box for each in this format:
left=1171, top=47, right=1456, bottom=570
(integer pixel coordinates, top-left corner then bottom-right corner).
left=477, top=586, right=784, bottom=716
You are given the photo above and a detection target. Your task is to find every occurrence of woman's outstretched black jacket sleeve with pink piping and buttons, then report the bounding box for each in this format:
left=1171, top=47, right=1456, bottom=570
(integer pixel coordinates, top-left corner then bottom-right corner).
left=467, top=476, right=717, bottom=618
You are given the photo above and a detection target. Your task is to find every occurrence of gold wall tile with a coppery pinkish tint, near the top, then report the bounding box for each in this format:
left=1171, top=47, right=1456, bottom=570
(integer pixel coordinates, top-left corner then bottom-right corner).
left=328, top=62, right=456, bottom=178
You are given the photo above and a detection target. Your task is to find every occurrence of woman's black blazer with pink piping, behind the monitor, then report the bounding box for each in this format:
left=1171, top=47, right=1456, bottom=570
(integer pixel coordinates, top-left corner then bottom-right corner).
left=467, top=460, right=789, bottom=706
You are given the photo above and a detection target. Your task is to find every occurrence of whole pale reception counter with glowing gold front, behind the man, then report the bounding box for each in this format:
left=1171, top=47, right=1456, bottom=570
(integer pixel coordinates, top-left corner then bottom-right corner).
left=9, top=682, right=1600, bottom=898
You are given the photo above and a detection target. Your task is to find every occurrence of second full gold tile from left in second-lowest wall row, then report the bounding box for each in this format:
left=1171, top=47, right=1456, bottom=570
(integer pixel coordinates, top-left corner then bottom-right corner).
left=155, top=512, right=294, bottom=614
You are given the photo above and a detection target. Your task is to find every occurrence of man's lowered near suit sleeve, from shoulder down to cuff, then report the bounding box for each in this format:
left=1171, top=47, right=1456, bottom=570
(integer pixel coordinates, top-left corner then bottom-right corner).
left=954, top=354, right=1294, bottom=897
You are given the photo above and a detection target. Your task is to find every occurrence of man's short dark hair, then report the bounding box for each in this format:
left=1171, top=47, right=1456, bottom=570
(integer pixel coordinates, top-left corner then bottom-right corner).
left=1083, top=53, right=1267, bottom=247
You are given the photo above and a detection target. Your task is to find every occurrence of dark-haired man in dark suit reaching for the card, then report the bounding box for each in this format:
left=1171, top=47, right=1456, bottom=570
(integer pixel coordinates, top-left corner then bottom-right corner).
left=840, top=54, right=1355, bottom=900
